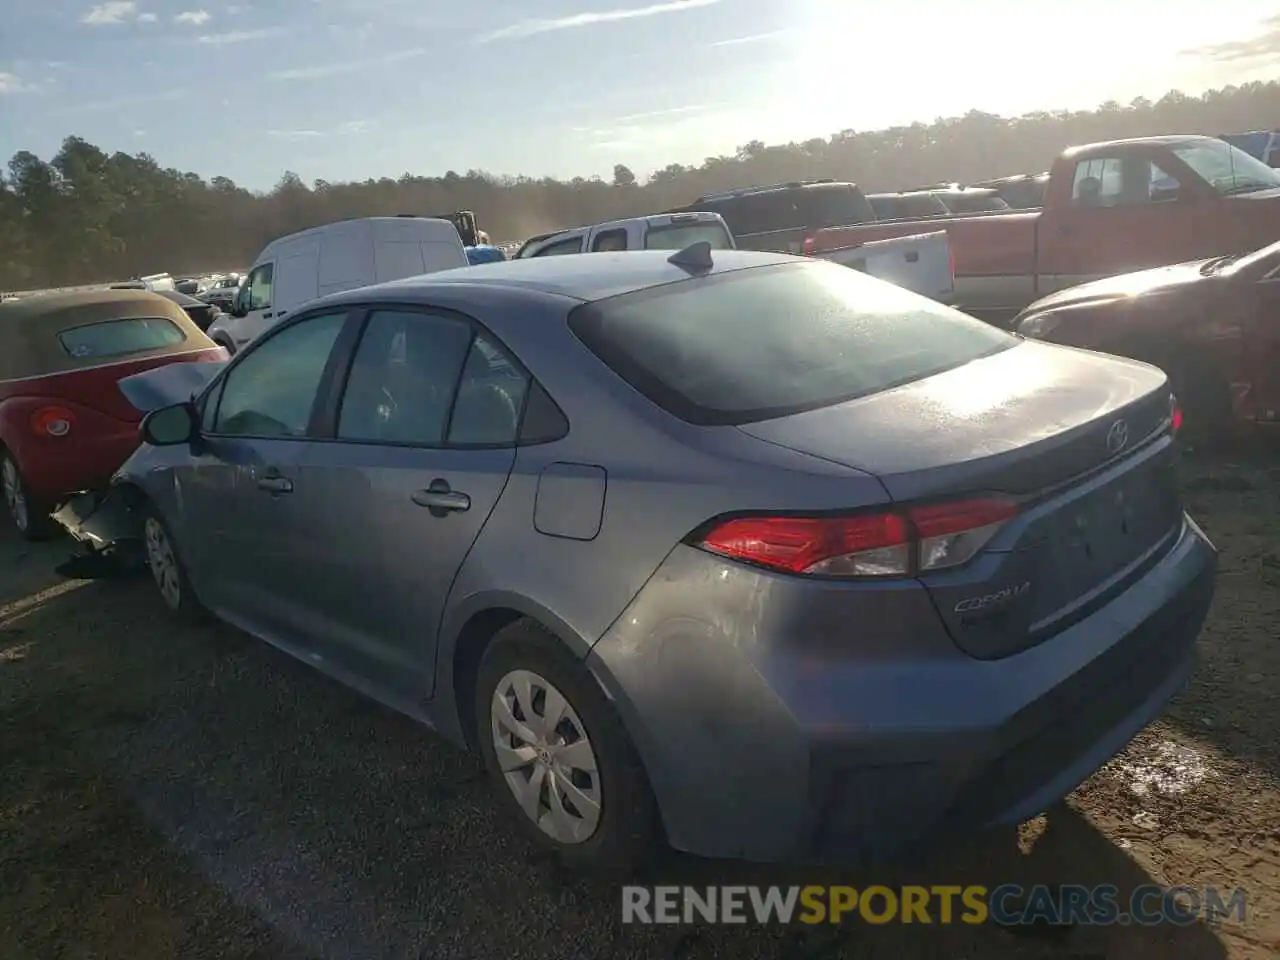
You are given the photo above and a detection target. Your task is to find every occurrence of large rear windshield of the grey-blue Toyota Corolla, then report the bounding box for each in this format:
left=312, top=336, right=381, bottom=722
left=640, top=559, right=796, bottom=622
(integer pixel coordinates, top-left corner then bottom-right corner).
left=570, top=262, right=1018, bottom=425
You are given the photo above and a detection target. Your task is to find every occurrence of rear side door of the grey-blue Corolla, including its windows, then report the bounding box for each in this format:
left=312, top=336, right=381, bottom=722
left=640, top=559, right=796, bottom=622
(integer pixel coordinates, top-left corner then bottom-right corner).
left=297, top=307, right=529, bottom=701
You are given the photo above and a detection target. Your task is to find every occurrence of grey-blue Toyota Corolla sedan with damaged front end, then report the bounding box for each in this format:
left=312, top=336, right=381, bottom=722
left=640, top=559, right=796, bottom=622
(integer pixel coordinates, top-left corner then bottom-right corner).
left=61, top=244, right=1216, bottom=867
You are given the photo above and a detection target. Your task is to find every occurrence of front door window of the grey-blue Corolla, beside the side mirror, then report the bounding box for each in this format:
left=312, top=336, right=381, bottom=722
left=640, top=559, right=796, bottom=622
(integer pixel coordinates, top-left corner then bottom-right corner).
left=206, top=312, right=347, bottom=436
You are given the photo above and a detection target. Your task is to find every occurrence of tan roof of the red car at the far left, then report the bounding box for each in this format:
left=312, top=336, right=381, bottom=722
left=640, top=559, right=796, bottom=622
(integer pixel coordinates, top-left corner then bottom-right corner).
left=0, top=289, right=214, bottom=380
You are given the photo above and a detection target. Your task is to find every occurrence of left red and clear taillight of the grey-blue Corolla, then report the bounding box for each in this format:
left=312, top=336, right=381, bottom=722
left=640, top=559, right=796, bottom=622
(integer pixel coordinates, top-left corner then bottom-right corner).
left=699, top=498, right=1018, bottom=577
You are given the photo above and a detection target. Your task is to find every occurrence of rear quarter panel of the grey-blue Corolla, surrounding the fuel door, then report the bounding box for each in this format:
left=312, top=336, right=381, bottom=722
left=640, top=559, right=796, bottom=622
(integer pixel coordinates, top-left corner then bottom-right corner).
left=436, top=293, right=887, bottom=730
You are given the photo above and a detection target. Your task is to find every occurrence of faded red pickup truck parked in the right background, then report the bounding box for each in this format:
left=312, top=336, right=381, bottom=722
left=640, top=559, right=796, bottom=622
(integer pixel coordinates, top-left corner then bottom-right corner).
left=804, top=136, right=1280, bottom=311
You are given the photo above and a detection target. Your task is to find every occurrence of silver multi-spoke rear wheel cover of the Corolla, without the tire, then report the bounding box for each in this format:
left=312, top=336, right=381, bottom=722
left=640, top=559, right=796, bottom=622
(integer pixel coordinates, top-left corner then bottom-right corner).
left=489, top=669, right=600, bottom=844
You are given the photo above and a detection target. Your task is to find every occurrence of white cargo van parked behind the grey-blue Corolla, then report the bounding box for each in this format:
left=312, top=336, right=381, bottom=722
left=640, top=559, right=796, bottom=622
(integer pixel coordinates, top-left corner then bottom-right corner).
left=209, top=216, right=468, bottom=353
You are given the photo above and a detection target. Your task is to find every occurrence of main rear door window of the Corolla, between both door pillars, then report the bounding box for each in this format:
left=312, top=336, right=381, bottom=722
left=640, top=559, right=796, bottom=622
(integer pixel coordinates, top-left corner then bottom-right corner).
left=338, top=310, right=471, bottom=447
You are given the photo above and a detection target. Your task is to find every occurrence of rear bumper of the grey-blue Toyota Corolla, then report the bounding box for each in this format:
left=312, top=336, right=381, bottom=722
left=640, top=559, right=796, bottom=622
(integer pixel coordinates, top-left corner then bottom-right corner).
left=588, top=517, right=1217, bottom=863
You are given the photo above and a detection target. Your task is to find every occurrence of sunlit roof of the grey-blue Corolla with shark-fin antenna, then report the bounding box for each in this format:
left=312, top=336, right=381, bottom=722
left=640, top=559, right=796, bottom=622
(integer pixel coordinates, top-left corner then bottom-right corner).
left=314, top=250, right=805, bottom=303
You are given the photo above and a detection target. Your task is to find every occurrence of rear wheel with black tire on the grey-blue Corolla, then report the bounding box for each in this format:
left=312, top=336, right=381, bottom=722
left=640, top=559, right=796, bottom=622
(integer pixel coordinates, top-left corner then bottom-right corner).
left=475, top=620, right=660, bottom=876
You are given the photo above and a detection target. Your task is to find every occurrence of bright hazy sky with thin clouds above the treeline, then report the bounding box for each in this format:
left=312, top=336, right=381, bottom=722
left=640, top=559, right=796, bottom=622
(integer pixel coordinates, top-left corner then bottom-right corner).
left=0, top=0, right=1280, bottom=189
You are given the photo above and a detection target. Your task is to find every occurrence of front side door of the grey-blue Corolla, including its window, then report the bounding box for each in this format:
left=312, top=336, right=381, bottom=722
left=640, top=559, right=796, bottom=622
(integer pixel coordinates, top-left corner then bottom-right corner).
left=179, top=308, right=347, bottom=643
